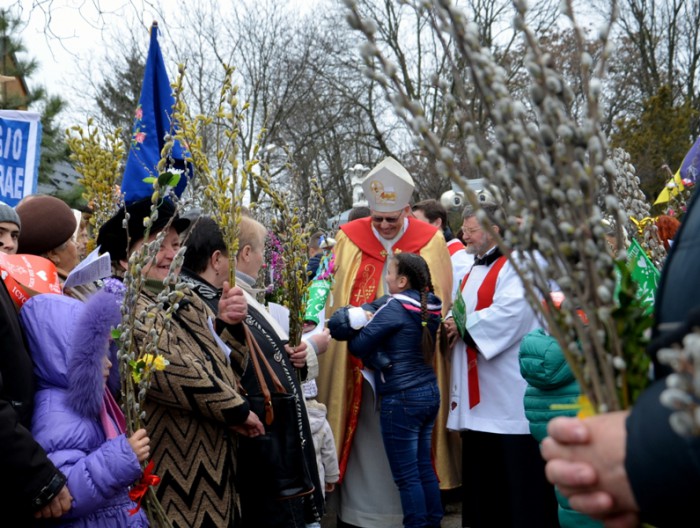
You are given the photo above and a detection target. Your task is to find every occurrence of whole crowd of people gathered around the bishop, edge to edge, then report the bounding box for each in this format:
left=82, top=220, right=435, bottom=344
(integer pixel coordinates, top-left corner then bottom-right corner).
left=0, top=154, right=700, bottom=528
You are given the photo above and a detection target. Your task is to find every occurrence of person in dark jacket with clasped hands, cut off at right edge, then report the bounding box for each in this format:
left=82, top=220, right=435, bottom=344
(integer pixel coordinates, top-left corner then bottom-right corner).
left=542, top=186, right=700, bottom=527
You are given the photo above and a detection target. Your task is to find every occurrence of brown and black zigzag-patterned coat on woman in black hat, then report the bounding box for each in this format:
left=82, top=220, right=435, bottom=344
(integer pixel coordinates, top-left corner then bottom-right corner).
left=134, top=282, right=250, bottom=527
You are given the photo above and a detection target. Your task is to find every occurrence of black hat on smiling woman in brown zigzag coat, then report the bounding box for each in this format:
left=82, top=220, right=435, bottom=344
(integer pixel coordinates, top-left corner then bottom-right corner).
left=97, top=197, right=190, bottom=261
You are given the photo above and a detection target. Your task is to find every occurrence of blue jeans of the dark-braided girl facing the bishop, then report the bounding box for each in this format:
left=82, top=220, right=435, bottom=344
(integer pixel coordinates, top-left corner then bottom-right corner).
left=380, top=382, right=444, bottom=528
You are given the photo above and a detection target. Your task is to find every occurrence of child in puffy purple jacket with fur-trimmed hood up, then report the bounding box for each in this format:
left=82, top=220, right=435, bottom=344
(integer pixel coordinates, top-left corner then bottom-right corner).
left=20, top=286, right=149, bottom=528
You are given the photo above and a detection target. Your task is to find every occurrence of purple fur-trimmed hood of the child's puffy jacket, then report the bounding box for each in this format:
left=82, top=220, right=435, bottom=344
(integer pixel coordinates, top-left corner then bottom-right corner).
left=20, top=290, right=121, bottom=417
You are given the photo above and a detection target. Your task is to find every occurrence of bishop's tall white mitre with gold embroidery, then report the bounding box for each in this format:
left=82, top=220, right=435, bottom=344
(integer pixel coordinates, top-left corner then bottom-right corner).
left=362, top=157, right=415, bottom=213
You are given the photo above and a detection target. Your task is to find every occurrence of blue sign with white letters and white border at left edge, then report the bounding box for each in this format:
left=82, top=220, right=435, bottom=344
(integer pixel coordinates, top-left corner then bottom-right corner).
left=0, top=110, right=41, bottom=207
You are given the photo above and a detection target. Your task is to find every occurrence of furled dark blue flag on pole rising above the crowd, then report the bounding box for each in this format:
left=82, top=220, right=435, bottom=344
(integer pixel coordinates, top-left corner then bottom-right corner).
left=121, top=22, right=192, bottom=204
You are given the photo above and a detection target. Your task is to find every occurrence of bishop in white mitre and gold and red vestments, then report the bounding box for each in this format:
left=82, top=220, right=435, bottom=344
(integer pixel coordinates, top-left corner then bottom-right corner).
left=317, top=158, right=461, bottom=528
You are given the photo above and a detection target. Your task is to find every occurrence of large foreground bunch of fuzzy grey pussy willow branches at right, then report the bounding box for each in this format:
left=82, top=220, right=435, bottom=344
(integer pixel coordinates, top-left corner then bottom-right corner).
left=346, top=0, right=649, bottom=412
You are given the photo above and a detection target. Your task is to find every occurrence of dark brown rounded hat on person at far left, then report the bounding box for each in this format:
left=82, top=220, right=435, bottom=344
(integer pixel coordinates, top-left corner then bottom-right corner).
left=16, top=195, right=77, bottom=255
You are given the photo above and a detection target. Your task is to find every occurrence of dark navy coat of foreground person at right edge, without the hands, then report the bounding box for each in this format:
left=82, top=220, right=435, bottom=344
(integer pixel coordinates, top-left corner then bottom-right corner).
left=625, top=186, right=700, bottom=528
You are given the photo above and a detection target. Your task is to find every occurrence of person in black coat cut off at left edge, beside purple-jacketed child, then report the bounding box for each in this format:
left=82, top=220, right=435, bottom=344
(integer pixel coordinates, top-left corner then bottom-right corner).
left=0, top=280, right=72, bottom=526
